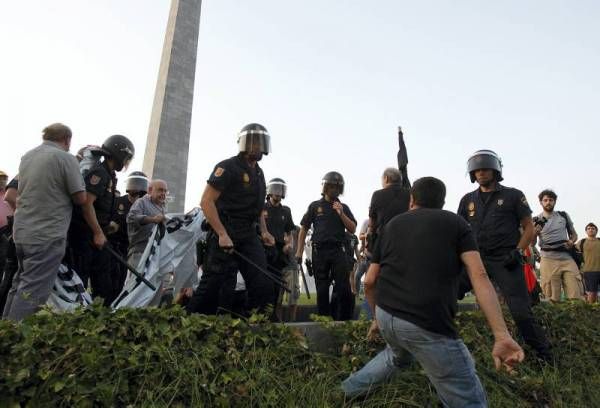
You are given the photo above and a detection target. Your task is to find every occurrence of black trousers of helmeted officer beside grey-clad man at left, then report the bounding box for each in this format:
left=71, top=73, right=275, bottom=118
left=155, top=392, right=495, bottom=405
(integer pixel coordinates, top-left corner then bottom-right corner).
left=65, top=231, right=118, bottom=307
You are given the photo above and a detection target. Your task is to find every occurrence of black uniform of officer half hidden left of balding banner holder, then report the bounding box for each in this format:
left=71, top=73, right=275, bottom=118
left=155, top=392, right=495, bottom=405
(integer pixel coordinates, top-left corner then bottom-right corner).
left=108, top=194, right=133, bottom=298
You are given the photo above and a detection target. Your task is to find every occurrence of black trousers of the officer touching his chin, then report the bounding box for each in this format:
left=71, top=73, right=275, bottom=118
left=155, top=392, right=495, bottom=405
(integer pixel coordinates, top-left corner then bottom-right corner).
left=312, top=244, right=354, bottom=320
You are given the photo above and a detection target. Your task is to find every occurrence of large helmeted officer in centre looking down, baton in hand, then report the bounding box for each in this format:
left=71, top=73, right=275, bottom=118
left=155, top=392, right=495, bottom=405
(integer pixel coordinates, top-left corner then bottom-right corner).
left=187, top=123, right=275, bottom=314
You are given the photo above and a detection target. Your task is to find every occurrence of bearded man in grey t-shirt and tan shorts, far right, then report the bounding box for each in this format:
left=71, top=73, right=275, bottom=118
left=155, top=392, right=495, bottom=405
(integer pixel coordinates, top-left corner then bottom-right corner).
left=534, top=190, right=583, bottom=302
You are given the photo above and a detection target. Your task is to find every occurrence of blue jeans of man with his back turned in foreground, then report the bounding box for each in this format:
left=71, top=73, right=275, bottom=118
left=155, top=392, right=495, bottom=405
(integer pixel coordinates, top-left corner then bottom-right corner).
left=342, top=307, right=487, bottom=408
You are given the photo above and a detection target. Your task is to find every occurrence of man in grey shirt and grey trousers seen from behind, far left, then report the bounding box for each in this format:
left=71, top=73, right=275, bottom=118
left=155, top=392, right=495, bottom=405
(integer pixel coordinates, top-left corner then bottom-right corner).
left=3, top=123, right=86, bottom=320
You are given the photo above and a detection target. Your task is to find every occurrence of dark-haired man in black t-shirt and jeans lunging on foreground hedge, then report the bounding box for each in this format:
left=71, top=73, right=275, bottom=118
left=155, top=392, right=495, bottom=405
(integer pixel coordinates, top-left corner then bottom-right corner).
left=342, top=177, right=524, bottom=407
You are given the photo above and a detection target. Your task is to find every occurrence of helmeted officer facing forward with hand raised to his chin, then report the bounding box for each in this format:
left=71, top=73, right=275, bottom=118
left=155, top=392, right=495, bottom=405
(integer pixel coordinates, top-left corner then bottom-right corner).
left=296, top=171, right=356, bottom=320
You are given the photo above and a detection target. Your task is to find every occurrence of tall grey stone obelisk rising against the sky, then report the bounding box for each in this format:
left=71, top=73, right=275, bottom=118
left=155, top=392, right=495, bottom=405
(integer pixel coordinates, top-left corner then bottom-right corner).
left=143, top=0, right=202, bottom=212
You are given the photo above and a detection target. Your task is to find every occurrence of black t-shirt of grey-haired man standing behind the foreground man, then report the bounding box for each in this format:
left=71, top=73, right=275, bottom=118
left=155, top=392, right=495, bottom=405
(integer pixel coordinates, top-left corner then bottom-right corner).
left=369, top=184, right=410, bottom=231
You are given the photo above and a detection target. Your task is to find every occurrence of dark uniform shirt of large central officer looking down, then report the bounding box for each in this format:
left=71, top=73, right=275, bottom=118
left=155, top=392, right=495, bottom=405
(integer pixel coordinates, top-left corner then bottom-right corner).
left=207, top=155, right=266, bottom=239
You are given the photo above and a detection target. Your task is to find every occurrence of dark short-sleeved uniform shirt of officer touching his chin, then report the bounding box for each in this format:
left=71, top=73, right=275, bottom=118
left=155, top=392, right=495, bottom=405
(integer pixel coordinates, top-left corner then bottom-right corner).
left=300, top=198, right=356, bottom=244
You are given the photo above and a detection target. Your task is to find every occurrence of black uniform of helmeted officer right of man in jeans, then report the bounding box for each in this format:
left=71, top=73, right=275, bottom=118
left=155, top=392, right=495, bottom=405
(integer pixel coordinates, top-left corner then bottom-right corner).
left=458, top=184, right=550, bottom=358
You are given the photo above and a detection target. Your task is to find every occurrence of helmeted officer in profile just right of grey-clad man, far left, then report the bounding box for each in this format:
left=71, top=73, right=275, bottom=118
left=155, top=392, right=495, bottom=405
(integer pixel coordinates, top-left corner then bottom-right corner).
left=67, top=135, right=135, bottom=306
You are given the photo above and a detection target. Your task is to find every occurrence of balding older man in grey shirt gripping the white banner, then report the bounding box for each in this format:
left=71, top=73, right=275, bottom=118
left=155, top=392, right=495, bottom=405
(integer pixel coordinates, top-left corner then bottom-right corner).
left=127, top=180, right=169, bottom=266
